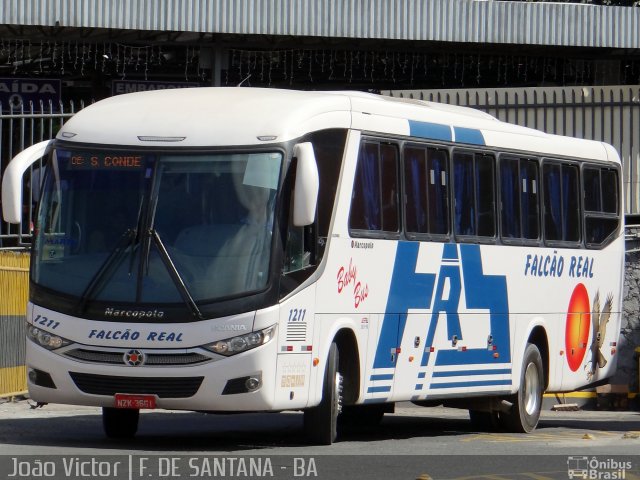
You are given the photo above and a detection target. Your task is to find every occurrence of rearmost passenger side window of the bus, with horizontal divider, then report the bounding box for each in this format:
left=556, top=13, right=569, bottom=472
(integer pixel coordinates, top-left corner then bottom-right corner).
left=582, top=167, right=620, bottom=246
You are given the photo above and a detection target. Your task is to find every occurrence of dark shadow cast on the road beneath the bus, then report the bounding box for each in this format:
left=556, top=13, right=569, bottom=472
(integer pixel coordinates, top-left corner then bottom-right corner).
left=0, top=411, right=640, bottom=454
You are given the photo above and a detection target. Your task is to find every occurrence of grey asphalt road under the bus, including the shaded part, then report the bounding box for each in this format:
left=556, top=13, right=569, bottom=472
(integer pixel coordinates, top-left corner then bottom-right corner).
left=0, top=400, right=640, bottom=480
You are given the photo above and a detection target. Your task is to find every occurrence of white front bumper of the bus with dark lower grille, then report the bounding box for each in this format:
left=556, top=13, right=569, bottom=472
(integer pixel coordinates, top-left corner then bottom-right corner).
left=27, top=341, right=278, bottom=412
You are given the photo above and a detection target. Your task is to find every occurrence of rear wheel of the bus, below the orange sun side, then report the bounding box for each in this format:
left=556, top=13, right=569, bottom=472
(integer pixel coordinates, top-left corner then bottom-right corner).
left=500, top=343, right=544, bottom=433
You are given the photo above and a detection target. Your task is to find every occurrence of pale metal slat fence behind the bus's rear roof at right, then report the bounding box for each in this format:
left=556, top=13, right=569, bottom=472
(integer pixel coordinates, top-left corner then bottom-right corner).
left=382, top=85, right=640, bottom=214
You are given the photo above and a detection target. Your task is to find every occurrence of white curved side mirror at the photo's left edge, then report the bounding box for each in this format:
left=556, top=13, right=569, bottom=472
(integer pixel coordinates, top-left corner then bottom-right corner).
left=2, top=140, right=53, bottom=223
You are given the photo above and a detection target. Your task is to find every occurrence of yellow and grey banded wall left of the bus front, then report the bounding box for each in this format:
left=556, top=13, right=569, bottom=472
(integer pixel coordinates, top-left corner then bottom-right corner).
left=0, top=251, right=29, bottom=397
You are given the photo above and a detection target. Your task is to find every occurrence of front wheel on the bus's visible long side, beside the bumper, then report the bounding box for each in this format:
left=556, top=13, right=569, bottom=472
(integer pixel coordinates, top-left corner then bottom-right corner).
left=304, top=343, right=342, bottom=445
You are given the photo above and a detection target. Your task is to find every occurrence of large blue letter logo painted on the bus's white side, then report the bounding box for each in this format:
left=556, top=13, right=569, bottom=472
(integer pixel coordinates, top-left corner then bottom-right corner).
left=373, top=242, right=511, bottom=368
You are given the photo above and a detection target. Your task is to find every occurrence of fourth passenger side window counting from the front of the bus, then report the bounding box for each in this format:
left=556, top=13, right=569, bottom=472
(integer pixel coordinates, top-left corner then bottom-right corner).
left=500, top=157, right=540, bottom=240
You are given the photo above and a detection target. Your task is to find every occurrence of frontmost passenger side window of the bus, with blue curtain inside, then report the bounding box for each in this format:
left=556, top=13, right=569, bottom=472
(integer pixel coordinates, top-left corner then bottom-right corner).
left=349, top=141, right=400, bottom=233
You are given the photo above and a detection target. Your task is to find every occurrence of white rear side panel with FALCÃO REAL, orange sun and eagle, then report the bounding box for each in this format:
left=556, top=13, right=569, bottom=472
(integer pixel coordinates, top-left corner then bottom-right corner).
left=500, top=241, right=622, bottom=391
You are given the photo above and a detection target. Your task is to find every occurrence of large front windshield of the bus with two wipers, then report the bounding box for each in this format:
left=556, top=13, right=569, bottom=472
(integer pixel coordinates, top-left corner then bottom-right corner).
left=32, top=149, right=282, bottom=311
